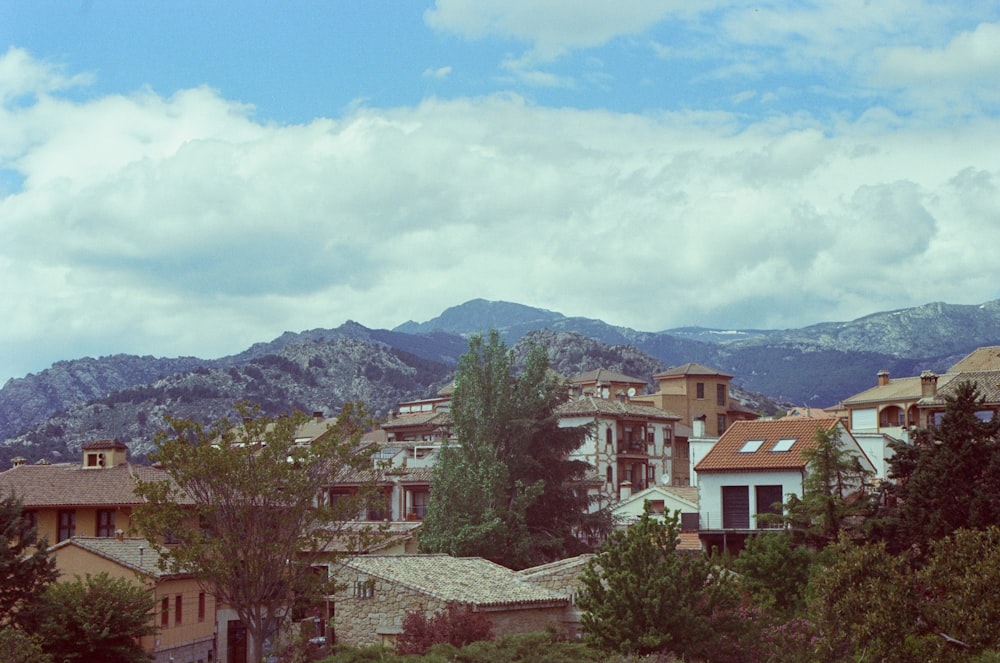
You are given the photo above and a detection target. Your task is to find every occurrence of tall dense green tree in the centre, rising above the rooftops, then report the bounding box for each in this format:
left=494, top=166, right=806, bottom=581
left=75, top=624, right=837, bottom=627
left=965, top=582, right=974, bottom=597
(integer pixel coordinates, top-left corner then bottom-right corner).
left=420, top=330, right=596, bottom=568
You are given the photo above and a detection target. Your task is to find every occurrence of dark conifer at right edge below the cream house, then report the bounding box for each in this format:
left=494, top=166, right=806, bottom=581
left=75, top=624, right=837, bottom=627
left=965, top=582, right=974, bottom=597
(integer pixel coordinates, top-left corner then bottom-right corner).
left=883, top=382, right=1000, bottom=554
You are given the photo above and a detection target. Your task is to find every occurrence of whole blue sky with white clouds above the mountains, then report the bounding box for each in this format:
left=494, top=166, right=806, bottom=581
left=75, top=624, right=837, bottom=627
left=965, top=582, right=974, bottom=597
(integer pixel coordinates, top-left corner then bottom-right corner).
left=0, top=0, right=1000, bottom=384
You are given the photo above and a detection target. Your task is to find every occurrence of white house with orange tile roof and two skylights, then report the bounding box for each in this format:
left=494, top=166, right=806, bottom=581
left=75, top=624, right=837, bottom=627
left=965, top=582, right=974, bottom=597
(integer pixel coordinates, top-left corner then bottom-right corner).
left=695, top=418, right=875, bottom=552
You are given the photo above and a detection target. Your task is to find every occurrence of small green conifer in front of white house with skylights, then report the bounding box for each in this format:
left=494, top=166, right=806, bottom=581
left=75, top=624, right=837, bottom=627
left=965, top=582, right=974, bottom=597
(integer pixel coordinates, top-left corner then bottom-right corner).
left=764, top=427, right=874, bottom=549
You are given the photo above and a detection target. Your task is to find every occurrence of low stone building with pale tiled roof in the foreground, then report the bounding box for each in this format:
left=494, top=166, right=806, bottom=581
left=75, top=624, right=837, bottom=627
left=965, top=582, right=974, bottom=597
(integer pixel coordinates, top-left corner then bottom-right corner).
left=335, top=555, right=572, bottom=646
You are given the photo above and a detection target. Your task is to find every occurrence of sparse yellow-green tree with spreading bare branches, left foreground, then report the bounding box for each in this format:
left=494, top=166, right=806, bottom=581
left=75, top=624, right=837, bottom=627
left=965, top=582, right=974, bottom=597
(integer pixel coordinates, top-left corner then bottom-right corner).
left=136, top=404, right=379, bottom=661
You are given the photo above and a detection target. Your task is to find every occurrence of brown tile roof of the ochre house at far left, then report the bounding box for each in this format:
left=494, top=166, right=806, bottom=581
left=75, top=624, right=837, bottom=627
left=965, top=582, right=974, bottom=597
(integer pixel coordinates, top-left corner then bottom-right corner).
left=0, top=463, right=190, bottom=508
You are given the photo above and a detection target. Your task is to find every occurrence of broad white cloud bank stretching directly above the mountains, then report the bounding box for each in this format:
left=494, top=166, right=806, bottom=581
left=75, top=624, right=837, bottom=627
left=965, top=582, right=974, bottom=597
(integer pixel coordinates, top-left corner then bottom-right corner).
left=0, top=48, right=1000, bottom=384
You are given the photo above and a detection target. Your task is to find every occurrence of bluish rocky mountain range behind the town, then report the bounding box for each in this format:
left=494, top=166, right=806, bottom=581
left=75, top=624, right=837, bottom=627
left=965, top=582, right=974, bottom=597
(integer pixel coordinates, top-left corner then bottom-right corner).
left=0, top=299, right=1000, bottom=467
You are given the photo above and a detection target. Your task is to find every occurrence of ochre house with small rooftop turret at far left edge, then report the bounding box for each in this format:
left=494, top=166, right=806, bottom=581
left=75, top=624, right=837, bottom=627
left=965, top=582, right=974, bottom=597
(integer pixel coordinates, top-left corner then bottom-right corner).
left=0, top=439, right=191, bottom=545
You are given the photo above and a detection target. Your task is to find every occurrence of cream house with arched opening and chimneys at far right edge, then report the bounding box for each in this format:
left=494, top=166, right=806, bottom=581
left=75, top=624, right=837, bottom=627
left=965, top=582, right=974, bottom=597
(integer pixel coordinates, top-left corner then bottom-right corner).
left=839, top=346, right=1000, bottom=440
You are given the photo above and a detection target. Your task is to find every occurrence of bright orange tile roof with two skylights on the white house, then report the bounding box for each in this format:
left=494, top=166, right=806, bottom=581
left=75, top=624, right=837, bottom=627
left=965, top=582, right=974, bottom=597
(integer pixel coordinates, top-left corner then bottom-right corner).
left=694, top=417, right=849, bottom=473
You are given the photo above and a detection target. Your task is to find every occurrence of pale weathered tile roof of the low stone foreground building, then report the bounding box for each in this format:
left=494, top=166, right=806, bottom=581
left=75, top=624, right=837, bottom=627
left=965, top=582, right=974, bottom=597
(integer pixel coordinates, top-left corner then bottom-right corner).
left=345, top=555, right=569, bottom=607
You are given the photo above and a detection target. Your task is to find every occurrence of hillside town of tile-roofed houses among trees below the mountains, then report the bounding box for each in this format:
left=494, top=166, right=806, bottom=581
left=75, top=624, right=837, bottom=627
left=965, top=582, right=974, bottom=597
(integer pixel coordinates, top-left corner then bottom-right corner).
left=0, top=334, right=1000, bottom=663
